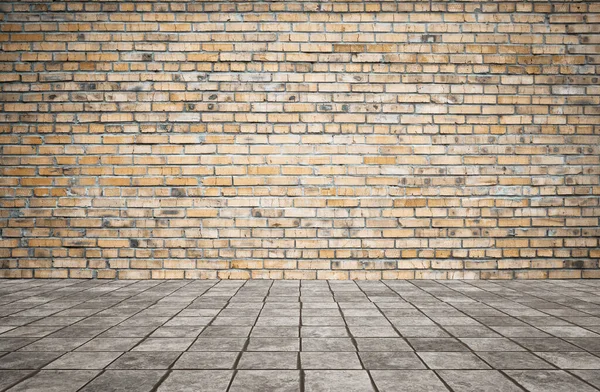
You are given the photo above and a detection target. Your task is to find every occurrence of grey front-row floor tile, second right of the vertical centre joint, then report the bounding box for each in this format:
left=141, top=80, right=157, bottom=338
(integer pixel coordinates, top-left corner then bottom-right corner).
left=371, top=370, right=448, bottom=392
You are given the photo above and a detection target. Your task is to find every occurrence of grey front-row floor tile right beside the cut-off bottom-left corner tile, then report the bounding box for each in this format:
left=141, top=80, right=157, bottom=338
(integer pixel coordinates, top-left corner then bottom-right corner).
left=9, top=370, right=99, bottom=392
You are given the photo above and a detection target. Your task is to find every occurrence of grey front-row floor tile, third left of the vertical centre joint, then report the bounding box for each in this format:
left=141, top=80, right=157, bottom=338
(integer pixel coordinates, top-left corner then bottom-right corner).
left=80, top=370, right=166, bottom=392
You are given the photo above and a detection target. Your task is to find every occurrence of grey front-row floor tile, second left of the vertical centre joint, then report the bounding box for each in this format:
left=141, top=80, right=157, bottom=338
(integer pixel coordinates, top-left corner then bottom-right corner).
left=157, top=370, right=233, bottom=392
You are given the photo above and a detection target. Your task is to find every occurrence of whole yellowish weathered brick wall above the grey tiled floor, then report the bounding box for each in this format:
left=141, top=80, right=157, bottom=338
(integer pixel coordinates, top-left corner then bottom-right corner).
left=0, top=0, right=600, bottom=279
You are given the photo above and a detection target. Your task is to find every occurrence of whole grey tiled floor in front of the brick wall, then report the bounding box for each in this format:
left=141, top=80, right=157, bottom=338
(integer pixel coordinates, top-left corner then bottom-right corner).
left=0, top=280, right=600, bottom=392
